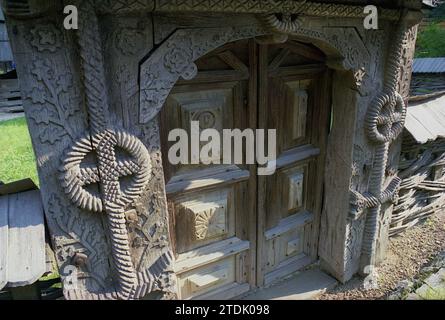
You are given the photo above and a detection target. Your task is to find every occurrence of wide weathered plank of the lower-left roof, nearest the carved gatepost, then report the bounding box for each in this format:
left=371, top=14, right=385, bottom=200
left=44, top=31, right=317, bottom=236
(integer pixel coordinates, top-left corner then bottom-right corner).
left=8, top=190, right=46, bottom=287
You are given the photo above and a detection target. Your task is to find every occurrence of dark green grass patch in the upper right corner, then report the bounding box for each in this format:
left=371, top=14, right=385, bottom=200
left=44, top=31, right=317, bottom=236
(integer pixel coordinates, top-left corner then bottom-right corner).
left=416, top=23, right=445, bottom=58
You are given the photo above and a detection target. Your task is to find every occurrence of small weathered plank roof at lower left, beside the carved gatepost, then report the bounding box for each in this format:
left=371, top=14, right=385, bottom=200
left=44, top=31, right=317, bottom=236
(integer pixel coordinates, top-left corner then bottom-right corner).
left=0, top=190, right=47, bottom=288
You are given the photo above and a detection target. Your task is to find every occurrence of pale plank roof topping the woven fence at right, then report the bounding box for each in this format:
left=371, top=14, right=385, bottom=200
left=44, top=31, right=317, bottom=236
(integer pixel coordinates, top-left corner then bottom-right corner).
left=405, top=94, right=445, bottom=143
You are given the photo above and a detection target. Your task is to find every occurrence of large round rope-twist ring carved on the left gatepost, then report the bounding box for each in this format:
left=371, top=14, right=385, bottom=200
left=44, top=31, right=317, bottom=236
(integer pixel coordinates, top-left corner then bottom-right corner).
left=60, top=130, right=151, bottom=212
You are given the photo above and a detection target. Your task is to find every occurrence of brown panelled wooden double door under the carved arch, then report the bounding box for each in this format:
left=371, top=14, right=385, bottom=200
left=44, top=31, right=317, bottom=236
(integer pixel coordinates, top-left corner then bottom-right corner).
left=160, top=39, right=330, bottom=299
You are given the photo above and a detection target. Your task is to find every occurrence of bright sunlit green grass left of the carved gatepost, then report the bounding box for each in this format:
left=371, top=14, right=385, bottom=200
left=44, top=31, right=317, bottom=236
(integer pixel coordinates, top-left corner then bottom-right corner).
left=0, top=118, right=39, bottom=185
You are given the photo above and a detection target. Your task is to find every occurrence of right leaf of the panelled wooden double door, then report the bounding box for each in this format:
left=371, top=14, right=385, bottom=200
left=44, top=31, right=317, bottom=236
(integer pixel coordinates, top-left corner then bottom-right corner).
left=257, top=41, right=329, bottom=286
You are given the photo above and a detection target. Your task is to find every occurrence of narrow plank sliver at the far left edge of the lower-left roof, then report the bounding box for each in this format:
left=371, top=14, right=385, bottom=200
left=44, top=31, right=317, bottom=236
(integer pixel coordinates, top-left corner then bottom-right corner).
left=0, top=195, right=9, bottom=289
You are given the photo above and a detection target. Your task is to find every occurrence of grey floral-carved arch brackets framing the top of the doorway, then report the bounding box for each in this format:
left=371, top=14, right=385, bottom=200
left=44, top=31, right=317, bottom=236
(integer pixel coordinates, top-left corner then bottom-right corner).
left=139, top=26, right=369, bottom=123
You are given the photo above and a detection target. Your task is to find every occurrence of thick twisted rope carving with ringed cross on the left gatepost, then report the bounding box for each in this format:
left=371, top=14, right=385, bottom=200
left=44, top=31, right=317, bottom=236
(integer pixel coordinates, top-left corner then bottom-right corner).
left=61, top=0, right=172, bottom=299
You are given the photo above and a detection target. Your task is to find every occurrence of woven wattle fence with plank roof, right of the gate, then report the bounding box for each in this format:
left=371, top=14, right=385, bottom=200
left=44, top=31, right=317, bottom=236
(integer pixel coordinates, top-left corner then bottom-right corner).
left=390, top=92, right=445, bottom=236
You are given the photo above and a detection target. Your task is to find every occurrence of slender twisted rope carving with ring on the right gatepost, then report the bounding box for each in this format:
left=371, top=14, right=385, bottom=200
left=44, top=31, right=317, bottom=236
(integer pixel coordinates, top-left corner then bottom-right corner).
left=362, top=19, right=406, bottom=272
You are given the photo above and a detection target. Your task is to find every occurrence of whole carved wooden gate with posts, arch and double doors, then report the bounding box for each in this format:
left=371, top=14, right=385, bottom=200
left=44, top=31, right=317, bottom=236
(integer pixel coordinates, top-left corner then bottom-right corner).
left=2, top=0, right=421, bottom=299
